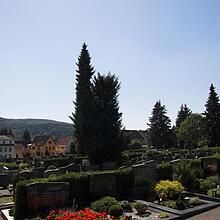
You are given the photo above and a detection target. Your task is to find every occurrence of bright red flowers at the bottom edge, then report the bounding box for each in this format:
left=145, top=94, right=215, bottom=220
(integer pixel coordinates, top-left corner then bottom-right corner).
left=46, top=208, right=115, bottom=220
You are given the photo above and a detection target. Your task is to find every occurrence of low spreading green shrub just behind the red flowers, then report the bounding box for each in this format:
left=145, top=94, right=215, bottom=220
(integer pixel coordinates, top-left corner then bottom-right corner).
left=91, top=196, right=118, bottom=212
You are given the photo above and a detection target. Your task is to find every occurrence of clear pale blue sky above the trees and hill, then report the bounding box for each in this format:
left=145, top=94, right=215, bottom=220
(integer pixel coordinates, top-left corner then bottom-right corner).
left=0, top=0, right=220, bottom=129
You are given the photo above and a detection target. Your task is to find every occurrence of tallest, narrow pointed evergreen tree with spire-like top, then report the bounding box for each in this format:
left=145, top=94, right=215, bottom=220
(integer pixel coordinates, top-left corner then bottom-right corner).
left=70, top=43, right=94, bottom=155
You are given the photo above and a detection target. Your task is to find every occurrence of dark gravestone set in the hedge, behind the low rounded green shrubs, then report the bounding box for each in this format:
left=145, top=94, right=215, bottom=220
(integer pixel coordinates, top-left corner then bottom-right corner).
left=89, top=173, right=116, bottom=196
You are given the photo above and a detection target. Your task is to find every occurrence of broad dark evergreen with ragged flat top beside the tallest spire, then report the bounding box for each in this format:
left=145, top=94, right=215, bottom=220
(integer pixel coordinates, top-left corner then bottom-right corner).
left=89, top=74, right=124, bottom=164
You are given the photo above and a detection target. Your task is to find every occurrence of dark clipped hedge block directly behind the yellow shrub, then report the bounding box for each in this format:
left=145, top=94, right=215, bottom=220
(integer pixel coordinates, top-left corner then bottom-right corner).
left=156, top=162, right=173, bottom=181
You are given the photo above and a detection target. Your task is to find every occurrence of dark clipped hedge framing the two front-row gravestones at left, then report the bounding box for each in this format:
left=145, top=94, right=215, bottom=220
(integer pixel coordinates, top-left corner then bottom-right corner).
left=14, top=168, right=132, bottom=220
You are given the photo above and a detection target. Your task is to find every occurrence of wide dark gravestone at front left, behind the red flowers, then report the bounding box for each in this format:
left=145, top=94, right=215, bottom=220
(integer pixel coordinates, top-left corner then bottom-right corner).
left=27, top=182, right=69, bottom=211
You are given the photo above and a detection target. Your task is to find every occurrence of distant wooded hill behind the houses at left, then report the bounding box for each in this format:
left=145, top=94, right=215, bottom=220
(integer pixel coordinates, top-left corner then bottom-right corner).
left=0, top=117, right=73, bottom=138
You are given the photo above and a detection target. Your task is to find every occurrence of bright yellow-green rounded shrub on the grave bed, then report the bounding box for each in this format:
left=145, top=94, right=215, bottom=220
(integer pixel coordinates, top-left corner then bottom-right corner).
left=155, top=180, right=184, bottom=201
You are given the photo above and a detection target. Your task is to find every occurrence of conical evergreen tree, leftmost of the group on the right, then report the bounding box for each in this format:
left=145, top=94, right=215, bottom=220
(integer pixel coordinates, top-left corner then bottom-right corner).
left=148, top=101, right=172, bottom=148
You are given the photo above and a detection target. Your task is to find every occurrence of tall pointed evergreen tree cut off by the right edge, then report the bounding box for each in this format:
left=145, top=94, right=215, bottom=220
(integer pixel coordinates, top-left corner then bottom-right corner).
left=204, top=84, right=220, bottom=147
